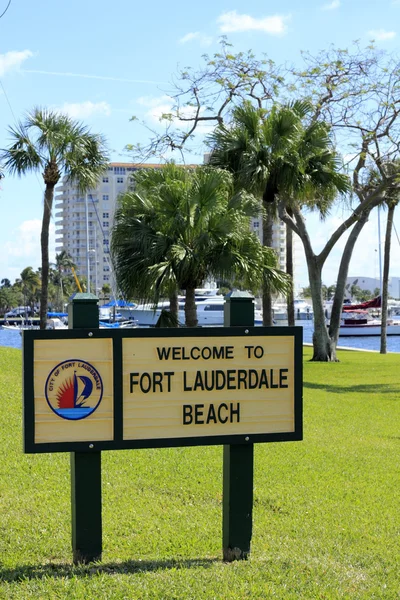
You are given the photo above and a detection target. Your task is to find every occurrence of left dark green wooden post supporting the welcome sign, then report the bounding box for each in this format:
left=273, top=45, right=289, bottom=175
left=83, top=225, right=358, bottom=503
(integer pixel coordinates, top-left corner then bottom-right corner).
left=68, top=294, right=102, bottom=563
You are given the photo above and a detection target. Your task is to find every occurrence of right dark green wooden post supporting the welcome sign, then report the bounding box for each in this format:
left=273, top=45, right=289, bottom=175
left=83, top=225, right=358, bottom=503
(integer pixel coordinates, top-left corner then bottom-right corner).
left=222, top=292, right=254, bottom=562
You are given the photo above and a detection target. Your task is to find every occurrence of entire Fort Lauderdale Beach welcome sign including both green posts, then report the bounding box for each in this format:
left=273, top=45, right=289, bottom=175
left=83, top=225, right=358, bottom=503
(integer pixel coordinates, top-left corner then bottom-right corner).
left=23, top=293, right=302, bottom=562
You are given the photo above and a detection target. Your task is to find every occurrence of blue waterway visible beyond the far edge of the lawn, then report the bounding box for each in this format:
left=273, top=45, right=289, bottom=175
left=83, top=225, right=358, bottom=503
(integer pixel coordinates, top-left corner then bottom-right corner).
left=0, top=321, right=400, bottom=352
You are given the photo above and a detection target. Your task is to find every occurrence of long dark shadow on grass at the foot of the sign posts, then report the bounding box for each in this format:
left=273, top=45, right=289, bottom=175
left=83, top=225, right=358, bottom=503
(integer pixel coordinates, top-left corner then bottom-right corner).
left=0, top=558, right=222, bottom=583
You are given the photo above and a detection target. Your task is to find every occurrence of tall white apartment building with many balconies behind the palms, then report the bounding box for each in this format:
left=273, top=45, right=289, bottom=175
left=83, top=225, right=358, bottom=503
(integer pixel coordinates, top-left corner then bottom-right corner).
left=55, top=163, right=294, bottom=295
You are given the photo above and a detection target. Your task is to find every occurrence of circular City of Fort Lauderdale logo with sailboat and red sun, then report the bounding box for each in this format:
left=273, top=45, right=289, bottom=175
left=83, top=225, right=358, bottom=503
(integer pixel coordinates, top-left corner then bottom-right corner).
left=44, top=358, right=103, bottom=421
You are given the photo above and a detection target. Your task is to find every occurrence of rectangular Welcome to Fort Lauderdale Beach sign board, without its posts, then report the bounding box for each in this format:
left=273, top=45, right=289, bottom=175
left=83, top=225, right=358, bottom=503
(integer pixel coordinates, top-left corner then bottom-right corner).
left=23, top=327, right=302, bottom=452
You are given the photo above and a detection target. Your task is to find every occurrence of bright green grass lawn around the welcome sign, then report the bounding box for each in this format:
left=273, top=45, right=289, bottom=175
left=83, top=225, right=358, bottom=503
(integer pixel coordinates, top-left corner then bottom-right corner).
left=0, top=348, right=400, bottom=600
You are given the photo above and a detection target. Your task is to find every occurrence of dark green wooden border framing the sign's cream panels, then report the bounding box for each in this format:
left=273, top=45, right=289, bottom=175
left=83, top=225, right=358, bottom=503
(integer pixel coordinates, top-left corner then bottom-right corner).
left=23, top=326, right=303, bottom=454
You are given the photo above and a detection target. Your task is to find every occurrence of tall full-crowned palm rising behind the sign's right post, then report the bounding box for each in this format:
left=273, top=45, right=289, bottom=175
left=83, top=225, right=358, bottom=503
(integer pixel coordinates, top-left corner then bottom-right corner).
left=209, top=101, right=344, bottom=325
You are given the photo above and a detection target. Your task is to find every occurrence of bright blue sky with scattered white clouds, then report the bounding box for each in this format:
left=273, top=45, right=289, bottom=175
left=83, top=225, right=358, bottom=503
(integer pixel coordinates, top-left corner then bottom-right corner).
left=0, top=0, right=400, bottom=285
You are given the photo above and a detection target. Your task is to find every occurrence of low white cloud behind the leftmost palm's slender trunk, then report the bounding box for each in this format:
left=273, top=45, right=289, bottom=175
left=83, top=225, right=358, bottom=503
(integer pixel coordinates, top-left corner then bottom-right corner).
left=4, top=219, right=55, bottom=270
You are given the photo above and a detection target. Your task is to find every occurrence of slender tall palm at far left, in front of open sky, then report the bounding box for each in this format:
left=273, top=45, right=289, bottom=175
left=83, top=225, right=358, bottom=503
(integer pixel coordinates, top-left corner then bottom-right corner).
left=0, top=108, right=108, bottom=329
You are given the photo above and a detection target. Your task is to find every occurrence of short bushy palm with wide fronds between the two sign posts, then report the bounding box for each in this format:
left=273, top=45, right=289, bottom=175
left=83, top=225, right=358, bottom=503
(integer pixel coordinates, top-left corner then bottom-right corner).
left=111, top=165, right=287, bottom=327
